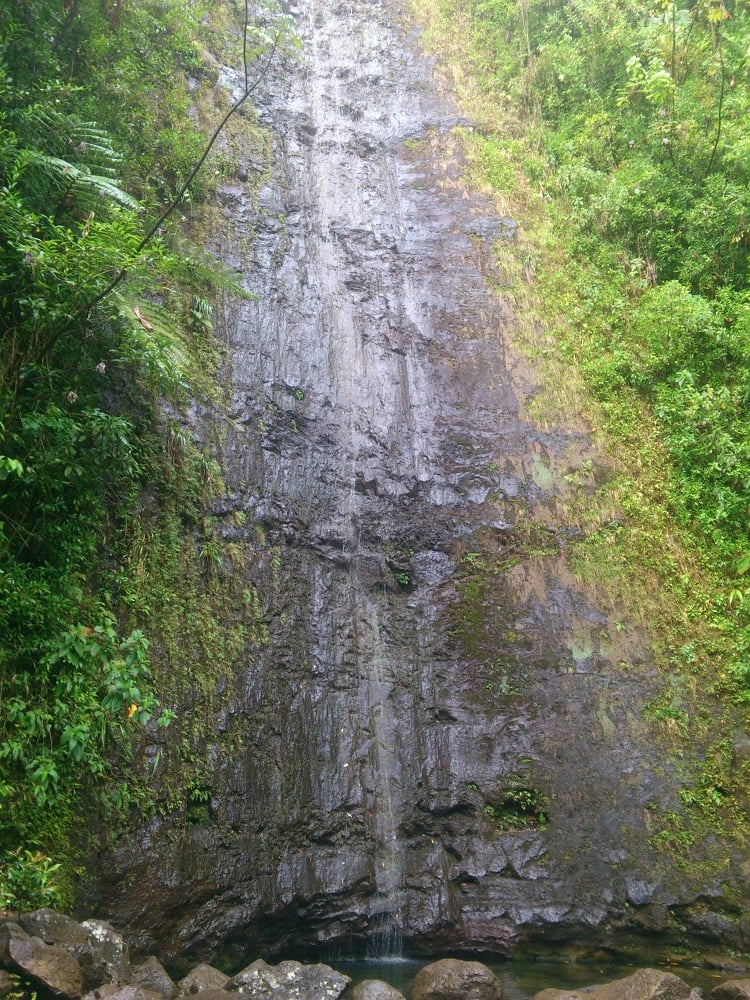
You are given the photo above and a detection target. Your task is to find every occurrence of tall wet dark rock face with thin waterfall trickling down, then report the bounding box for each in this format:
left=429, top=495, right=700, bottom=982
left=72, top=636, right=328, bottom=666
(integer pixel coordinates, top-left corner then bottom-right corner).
left=91, top=0, right=748, bottom=967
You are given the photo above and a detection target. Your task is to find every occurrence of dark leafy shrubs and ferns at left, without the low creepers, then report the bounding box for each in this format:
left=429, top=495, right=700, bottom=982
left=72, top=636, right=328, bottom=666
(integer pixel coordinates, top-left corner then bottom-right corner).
left=0, top=0, right=270, bottom=909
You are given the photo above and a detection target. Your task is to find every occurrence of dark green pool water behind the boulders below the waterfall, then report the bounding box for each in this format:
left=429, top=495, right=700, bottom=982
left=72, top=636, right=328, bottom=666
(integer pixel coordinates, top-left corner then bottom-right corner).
left=330, top=959, right=736, bottom=1000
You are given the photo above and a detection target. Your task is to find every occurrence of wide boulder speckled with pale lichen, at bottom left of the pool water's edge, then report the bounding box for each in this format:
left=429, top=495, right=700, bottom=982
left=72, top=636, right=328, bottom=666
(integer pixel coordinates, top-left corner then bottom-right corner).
left=227, top=959, right=351, bottom=1000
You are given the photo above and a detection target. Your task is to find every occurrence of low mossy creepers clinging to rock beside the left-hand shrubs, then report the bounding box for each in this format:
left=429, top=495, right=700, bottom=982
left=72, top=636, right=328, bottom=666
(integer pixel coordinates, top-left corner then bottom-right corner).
left=107, top=428, right=267, bottom=836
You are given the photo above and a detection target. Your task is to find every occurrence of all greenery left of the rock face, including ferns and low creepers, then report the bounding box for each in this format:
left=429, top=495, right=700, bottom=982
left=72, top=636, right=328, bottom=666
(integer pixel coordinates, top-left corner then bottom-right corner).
left=0, top=0, right=288, bottom=909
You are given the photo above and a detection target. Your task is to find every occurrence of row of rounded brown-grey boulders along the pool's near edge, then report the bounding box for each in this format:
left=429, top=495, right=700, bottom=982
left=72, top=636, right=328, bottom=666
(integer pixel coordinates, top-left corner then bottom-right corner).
left=0, top=909, right=750, bottom=1000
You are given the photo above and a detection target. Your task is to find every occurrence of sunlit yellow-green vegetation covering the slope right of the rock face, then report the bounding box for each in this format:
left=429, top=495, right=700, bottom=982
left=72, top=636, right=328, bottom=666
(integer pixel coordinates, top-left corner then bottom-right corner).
left=414, top=0, right=750, bottom=863
